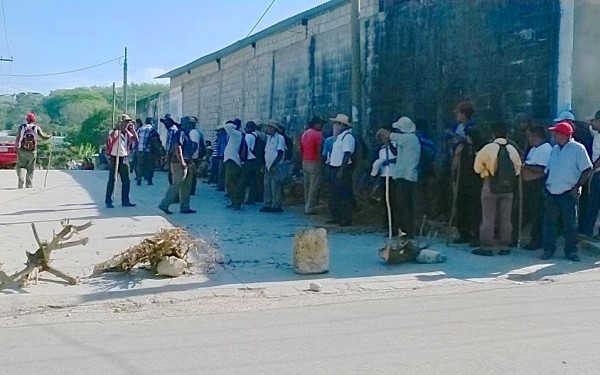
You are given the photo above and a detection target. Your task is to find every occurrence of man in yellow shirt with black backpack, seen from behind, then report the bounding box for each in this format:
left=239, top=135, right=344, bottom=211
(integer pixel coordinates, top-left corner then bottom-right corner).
left=472, top=122, right=521, bottom=256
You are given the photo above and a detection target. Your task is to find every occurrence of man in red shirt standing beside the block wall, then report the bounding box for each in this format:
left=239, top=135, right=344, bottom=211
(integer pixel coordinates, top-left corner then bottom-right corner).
left=300, top=116, right=325, bottom=215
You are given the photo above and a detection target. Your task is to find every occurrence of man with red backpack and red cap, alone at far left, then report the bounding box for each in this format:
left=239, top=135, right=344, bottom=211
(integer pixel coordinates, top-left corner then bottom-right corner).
left=15, top=112, right=52, bottom=189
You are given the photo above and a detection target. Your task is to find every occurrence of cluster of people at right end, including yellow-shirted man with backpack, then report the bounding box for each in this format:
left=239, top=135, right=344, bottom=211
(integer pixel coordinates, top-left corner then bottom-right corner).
left=436, top=102, right=600, bottom=261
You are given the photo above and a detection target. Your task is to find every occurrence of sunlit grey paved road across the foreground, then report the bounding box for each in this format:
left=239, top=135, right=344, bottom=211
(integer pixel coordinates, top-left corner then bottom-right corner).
left=0, top=279, right=600, bottom=375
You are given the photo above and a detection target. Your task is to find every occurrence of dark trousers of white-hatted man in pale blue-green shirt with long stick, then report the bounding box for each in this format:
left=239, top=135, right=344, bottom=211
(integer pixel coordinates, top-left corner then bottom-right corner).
left=390, top=178, right=417, bottom=237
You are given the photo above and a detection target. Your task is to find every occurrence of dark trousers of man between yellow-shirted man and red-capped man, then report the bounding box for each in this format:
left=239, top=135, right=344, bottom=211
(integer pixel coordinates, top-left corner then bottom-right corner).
left=523, top=178, right=544, bottom=247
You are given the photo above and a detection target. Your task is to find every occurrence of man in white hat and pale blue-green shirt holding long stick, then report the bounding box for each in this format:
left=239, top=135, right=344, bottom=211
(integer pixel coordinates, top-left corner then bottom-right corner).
left=378, top=117, right=421, bottom=237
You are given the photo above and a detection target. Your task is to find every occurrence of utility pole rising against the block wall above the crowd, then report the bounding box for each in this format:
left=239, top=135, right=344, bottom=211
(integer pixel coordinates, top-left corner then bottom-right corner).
left=350, top=0, right=363, bottom=144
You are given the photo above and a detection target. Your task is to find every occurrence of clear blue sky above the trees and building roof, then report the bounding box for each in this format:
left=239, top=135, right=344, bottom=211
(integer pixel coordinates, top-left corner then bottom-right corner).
left=0, top=0, right=326, bottom=94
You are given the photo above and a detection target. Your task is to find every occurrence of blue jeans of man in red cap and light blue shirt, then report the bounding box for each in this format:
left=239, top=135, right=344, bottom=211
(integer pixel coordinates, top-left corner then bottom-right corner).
left=544, top=191, right=577, bottom=256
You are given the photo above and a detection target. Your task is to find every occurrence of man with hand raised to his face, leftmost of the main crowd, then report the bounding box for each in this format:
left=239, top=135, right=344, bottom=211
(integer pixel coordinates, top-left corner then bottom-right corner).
left=104, top=114, right=138, bottom=208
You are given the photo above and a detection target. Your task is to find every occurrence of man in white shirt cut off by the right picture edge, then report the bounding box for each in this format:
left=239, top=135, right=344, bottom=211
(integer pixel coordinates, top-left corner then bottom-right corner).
left=581, top=111, right=600, bottom=239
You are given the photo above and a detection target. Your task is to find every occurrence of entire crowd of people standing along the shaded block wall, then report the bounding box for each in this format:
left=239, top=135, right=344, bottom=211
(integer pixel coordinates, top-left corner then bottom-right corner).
left=101, top=102, right=600, bottom=261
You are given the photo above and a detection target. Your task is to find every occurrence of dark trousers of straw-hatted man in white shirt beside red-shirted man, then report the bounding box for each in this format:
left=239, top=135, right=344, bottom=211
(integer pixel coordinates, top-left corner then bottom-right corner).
left=329, top=167, right=354, bottom=225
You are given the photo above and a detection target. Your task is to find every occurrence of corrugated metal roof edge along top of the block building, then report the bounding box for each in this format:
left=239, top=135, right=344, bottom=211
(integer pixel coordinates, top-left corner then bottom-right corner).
left=156, top=0, right=350, bottom=78
